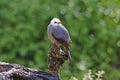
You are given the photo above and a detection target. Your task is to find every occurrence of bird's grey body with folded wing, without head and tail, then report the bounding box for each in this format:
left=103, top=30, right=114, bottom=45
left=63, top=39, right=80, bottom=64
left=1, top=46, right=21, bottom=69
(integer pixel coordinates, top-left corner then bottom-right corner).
left=48, top=24, right=71, bottom=46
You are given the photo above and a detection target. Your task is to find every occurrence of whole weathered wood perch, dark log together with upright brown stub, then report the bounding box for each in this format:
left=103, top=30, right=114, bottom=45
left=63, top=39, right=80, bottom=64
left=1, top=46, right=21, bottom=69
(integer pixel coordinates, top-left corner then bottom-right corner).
left=0, top=46, right=68, bottom=80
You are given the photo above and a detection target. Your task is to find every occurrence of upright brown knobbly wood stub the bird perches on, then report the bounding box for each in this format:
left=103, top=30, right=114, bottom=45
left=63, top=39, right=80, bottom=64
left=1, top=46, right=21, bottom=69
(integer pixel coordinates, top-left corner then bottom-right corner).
left=48, top=45, right=68, bottom=74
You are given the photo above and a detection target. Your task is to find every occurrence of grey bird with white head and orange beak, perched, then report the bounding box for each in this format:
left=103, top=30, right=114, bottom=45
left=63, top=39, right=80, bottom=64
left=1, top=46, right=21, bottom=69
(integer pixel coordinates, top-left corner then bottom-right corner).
left=47, top=18, right=72, bottom=64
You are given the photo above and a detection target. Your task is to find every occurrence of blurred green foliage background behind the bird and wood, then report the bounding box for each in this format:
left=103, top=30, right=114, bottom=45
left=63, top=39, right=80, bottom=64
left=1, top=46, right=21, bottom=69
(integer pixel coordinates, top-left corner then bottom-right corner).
left=0, top=0, right=120, bottom=80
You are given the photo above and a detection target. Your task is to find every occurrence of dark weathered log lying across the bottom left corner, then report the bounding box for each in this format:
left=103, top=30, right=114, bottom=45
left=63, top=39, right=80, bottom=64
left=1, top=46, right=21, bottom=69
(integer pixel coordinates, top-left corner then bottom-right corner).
left=0, top=62, right=60, bottom=80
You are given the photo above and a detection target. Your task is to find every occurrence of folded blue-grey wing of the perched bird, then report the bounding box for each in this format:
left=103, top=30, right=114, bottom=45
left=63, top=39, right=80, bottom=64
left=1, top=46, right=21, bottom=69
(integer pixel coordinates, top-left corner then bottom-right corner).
left=52, top=26, right=70, bottom=46
